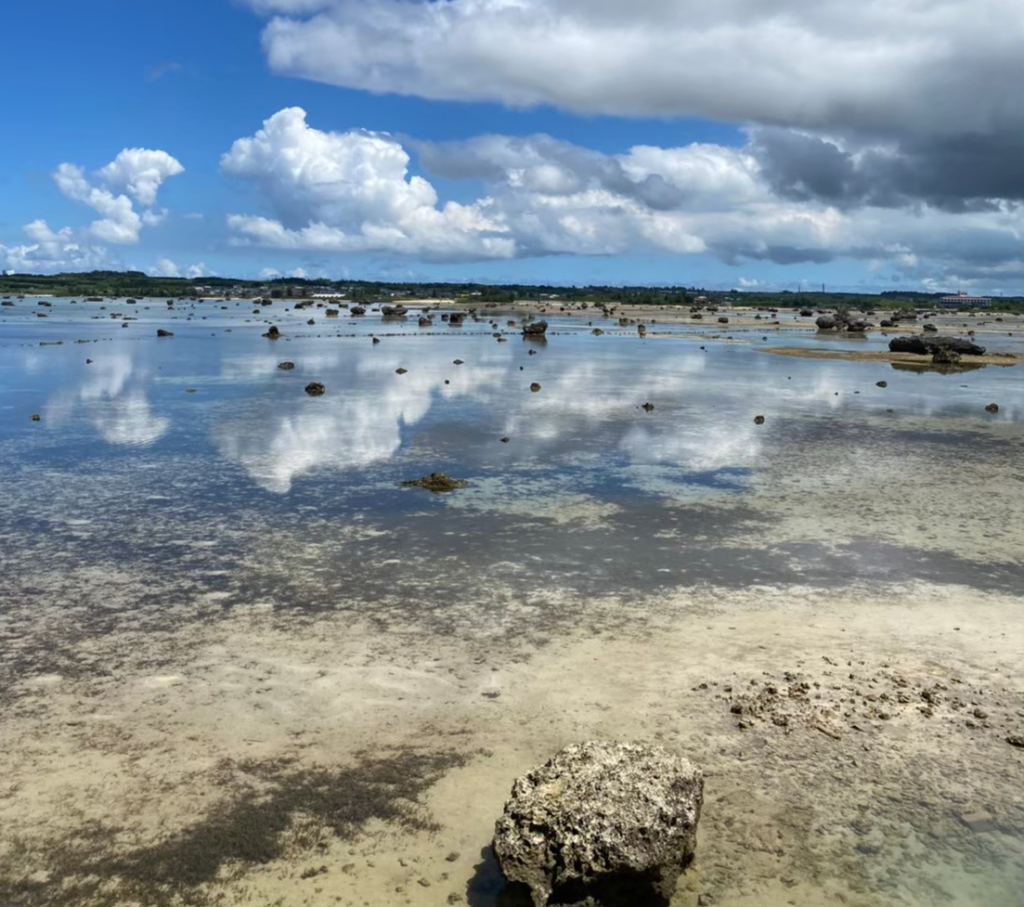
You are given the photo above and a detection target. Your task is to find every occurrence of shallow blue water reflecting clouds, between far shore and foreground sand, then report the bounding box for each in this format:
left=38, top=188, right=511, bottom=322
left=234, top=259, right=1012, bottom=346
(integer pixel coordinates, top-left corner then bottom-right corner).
left=0, top=300, right=1024, bottom=903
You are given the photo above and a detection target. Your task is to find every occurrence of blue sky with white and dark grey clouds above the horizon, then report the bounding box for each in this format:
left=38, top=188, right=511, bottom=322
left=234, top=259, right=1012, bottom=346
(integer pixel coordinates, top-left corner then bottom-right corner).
left=0, top=0, right=1024, bottom=295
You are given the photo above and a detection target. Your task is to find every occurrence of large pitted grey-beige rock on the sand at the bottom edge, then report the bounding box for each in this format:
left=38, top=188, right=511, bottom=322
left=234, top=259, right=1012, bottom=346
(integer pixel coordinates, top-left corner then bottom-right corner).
left=494, top=741, right=703, bottom=907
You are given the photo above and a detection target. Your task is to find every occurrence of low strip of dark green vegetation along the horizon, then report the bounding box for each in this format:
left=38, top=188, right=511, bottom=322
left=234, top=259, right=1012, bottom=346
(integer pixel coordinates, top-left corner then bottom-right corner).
left=0, top=271, right=1024, bottom=312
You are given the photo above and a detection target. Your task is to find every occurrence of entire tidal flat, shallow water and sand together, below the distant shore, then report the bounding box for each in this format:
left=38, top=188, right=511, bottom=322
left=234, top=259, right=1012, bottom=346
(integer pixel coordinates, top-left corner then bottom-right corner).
left=0, top=299, right=1024, bottom=907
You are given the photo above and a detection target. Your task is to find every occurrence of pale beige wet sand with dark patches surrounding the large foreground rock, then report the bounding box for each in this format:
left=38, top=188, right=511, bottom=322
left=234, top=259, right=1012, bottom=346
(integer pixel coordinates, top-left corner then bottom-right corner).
left=0, top=586, right=1024, bottom=905
